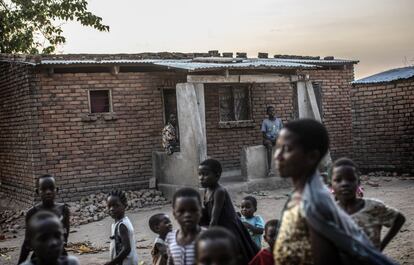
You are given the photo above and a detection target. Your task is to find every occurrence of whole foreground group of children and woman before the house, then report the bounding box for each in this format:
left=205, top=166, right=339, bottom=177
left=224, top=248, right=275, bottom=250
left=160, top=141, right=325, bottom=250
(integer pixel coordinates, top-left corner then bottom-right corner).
left=19, top=119, right=405, bottom=265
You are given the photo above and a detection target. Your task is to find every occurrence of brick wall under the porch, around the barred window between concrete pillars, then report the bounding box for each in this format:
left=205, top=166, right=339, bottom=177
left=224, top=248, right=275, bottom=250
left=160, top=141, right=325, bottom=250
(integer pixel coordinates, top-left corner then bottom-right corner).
left=204, top=82, right=293, bottom=169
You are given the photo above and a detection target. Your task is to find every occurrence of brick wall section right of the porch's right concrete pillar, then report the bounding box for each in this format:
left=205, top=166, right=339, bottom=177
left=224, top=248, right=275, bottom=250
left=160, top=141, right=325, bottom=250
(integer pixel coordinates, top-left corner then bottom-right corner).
left=301, top=65, right=354, bottom=160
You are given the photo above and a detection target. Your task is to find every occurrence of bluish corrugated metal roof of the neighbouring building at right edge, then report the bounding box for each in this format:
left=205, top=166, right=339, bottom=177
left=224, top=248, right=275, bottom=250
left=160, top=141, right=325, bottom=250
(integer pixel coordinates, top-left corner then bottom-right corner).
left=352, top=66, right=414, bottom=84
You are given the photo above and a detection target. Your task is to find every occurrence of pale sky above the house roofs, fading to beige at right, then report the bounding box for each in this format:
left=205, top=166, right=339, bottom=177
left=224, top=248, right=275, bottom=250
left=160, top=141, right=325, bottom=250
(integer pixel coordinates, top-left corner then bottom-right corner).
left=59, top=0, right=414, bottom=78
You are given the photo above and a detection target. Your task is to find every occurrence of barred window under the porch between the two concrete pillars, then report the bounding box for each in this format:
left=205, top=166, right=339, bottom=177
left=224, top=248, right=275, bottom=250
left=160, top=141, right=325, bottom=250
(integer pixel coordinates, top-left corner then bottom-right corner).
left=219, top=84, right=251, bottom=122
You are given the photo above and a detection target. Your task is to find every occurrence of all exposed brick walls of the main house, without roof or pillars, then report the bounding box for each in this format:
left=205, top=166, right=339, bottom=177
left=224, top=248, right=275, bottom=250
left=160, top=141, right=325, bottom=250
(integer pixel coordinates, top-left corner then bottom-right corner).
left=0, top=59, right=353, bottom=202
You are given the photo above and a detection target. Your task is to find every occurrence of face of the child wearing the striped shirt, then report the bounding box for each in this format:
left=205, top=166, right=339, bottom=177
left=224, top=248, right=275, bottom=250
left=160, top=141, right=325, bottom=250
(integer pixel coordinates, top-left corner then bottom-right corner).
left=173, top=197, right=201, bottom=229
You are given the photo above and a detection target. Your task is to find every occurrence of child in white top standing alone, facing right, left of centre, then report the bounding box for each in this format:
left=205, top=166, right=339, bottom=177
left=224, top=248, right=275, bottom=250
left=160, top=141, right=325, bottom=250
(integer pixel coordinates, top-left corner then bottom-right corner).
left=105, top=191, right=138, bottom=265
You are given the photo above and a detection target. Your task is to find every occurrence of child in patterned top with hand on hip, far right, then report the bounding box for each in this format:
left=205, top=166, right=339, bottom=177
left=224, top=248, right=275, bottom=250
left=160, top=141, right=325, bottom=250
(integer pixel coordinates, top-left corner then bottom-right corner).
left=332, top=158, right=405, bottom=251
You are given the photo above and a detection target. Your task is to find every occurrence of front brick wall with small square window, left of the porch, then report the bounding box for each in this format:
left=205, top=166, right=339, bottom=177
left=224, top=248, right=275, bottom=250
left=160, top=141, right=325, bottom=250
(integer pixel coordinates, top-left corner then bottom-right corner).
left=33, top=72, right=186, bottom=200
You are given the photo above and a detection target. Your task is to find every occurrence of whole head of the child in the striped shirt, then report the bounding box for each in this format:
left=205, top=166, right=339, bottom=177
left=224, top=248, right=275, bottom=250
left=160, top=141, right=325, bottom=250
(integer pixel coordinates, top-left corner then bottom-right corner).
left=172, top=188, right=201, bottom=231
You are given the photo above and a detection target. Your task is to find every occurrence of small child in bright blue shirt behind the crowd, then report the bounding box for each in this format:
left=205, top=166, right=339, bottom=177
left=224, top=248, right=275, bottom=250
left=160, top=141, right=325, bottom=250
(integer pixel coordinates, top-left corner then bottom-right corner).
left=241, top=196, right=264, bottom=248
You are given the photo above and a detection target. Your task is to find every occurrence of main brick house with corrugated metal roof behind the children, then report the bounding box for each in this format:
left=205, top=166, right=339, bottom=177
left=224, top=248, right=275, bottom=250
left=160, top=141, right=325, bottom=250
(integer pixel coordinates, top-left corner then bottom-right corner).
left=0, top=52, right=357, bottom=203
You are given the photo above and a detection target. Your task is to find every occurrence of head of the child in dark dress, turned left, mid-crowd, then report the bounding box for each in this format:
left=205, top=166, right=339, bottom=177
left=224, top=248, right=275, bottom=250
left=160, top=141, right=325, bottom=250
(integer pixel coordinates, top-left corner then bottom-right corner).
left=198, top=158, right=222, bottom=188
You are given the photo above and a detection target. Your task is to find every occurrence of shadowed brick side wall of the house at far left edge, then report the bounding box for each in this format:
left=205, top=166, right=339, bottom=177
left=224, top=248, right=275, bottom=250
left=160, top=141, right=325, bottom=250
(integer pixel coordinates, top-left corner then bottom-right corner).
left=0, top=62, right=36, bottom=203
